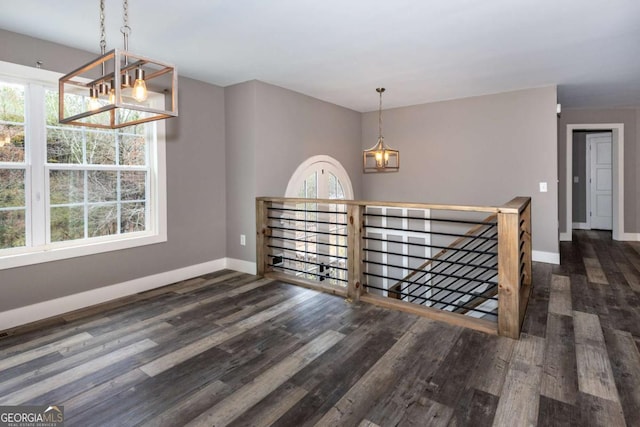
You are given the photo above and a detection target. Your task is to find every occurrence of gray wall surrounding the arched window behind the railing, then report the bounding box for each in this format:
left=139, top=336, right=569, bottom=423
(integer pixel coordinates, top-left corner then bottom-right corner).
left=225, top=81, right=362, bottom=261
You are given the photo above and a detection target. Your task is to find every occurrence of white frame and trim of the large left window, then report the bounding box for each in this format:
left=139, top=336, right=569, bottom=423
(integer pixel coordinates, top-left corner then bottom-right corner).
left=0, top=61, right=167, bottom=270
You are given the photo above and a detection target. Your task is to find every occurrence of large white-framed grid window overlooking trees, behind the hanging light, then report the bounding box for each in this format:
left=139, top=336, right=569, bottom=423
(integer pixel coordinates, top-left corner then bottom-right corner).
left=0, top=63, right=166, bottom=268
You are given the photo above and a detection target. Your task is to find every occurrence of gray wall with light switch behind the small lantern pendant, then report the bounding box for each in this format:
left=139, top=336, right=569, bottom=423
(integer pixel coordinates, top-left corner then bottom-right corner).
left=362, top=87, right=558, bottom=253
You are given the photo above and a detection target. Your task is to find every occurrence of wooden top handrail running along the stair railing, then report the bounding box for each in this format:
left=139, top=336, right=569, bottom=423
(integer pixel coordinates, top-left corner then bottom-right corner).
left=256, top=197, right=531, bottom=217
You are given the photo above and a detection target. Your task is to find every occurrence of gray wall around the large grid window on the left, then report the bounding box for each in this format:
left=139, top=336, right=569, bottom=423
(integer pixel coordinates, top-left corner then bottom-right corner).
left=0, top=30, right=226, bottom=310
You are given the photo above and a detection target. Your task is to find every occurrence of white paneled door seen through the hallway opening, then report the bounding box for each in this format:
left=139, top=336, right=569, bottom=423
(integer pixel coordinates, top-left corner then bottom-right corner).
left=587, top=132, right=613, bottom=230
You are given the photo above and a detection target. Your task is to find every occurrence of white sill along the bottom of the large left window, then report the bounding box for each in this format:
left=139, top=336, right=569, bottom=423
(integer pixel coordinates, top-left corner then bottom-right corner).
left=0, top=233, right=167, bottom=270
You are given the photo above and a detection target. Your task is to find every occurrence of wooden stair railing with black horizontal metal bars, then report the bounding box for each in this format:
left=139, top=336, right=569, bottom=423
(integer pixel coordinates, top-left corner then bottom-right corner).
left=256, top=197, right=531, bottom=338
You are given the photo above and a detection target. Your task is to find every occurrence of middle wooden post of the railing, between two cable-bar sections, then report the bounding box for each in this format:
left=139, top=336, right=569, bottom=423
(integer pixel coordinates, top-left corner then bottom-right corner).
left=347, top=205, right=364, bottom=301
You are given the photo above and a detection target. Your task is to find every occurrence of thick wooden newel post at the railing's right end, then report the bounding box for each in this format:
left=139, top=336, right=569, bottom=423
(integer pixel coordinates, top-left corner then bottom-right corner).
left=498, top=210, right=520, bottom=339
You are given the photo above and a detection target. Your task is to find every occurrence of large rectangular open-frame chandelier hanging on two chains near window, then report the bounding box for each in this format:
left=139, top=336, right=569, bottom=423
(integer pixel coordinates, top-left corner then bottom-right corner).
left=59, top=0, right=178, bottom=129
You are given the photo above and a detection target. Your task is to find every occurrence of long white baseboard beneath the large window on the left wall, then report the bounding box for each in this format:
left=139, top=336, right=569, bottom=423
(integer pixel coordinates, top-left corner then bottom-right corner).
left=0, top=258, right=227, bottom=331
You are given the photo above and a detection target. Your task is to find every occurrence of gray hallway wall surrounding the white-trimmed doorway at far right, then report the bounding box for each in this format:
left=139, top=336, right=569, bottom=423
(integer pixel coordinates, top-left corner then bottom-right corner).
left=558, top=108, right=640, bottom=233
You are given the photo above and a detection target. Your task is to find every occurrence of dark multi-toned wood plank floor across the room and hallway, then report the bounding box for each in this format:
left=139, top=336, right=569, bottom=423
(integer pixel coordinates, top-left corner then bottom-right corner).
left=0, top=231, right=640, bottom=426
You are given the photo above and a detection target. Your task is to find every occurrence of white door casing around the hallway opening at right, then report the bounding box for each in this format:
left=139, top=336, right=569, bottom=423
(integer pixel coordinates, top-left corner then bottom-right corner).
left=560, top=123, right=628, bottom=242
